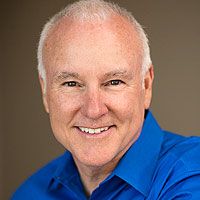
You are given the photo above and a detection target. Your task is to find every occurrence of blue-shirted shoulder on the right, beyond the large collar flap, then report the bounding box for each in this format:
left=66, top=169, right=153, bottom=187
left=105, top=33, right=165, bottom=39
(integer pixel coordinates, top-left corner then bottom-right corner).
left=154, top=132, right=200, bottom=199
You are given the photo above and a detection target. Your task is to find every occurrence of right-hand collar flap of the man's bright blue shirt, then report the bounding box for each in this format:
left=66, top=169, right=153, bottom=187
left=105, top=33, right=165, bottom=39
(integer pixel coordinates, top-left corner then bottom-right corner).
left=112, top=111, right=163, bottom=196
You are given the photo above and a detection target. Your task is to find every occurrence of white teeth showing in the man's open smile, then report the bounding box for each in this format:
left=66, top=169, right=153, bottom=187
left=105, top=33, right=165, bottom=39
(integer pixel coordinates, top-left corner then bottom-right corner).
left=77, top=125, right=114, bottom=135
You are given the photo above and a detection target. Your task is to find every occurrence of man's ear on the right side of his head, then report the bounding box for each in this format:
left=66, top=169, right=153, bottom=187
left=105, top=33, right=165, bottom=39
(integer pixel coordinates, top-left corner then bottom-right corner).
left=144, top=65, right=154, bottom=109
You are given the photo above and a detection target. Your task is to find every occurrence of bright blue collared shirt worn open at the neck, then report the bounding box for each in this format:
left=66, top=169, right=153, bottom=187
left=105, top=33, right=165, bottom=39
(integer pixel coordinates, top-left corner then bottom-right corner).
left=12, top=111, right=200, bottom=200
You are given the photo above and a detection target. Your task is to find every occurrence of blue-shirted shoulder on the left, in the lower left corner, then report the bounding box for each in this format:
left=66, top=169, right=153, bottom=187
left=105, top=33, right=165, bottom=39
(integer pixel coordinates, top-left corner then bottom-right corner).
left=11, top=152, right=64, bottom=200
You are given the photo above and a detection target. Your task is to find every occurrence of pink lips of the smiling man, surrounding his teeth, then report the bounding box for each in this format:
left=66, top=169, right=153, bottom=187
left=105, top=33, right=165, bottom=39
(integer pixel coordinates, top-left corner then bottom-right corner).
left=75, top=125, right=116, bottom=138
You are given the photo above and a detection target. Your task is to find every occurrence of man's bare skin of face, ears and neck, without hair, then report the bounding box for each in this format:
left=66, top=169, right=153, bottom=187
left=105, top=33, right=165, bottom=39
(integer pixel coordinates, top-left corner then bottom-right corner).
left=40, top=16, right=154, bottom=195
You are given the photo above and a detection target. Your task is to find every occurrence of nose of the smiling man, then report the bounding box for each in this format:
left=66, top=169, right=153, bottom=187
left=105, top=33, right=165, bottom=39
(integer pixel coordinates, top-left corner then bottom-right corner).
left=81, top=88, right=108, bottom=120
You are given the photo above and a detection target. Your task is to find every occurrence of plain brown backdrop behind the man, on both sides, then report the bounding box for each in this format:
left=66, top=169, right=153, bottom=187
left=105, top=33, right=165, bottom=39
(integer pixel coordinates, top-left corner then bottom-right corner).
left=0, top=0, right=200, bottom=199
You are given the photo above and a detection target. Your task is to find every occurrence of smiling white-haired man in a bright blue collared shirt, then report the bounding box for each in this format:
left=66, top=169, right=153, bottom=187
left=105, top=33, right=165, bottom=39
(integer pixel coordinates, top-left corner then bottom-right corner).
left=12, top=0, right=200, bottom=200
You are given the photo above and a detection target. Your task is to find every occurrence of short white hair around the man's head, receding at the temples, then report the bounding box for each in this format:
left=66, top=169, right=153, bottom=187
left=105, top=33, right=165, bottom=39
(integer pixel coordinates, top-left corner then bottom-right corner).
left=37, top=0, right=152, bottom=84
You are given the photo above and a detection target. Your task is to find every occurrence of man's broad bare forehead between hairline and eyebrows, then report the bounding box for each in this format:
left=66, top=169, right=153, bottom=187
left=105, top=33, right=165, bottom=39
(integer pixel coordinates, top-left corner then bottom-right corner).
left=43, top=16, right=141, bottom=74
